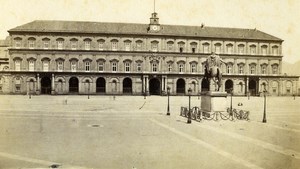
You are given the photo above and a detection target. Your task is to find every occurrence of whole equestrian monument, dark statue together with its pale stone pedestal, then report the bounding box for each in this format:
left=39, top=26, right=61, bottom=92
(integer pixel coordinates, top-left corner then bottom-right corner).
left=201, top=52, right=227, bottom=112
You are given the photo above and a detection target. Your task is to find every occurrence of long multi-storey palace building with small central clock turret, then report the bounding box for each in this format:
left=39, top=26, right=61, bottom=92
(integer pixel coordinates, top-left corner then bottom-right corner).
left=0, top=12, right=298, bottom=96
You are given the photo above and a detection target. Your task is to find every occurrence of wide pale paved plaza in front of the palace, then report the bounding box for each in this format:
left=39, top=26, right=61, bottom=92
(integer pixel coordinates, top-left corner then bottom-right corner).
left=0, top=95, right=300, bottom=169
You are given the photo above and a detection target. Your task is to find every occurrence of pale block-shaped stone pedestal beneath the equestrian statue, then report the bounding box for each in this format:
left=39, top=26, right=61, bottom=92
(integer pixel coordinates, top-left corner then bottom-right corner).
left=201, top=91, right=227, bottom=112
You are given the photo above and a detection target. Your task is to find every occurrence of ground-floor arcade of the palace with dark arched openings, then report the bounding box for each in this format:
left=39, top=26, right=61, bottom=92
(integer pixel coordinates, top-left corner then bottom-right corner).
left=0, top=72, right=298, bottom=96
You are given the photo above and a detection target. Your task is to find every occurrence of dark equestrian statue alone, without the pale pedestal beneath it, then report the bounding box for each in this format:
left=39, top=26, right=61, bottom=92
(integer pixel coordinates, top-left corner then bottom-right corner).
left=204, top=52, right=226, bottom=91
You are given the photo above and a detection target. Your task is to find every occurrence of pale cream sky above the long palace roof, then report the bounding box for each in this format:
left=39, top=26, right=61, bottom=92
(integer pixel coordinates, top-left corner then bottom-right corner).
left=0, top=0, right=300, bottom=63
